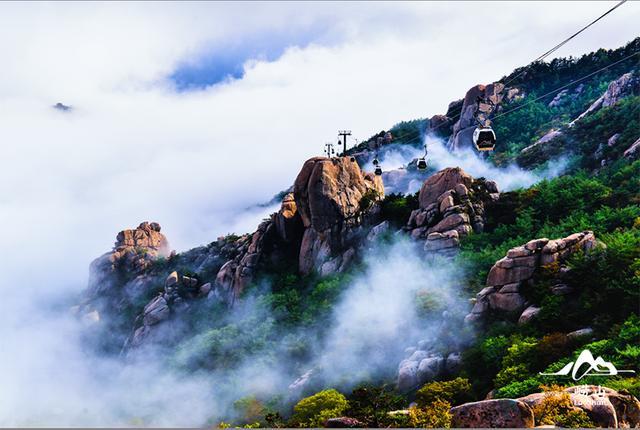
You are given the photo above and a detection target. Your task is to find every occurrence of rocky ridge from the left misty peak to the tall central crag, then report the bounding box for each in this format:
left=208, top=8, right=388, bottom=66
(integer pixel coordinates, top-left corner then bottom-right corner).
left=76, top=157, right=384, bottom=351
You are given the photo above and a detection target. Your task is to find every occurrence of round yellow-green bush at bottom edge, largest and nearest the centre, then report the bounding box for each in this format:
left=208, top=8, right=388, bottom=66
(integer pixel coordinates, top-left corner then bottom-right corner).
left=291, top=389, right=349, bottom=427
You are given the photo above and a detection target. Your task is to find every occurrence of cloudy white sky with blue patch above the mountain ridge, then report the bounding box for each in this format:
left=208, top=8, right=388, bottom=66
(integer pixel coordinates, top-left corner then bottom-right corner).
left=0, top=2, right=640, bottom=293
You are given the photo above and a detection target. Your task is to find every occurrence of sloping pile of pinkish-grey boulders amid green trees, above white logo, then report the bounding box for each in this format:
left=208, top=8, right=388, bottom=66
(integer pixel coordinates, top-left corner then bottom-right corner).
left=465, top=231, right=596, bottom=323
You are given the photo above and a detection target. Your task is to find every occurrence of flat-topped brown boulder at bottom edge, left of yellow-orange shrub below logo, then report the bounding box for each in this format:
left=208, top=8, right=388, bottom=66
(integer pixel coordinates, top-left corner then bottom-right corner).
left=451, top=399, right=534, bottom=428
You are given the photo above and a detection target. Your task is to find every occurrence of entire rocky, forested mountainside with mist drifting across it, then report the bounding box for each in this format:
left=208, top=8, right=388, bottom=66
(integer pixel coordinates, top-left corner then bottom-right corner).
left=73, top=38, right=640, bottom=427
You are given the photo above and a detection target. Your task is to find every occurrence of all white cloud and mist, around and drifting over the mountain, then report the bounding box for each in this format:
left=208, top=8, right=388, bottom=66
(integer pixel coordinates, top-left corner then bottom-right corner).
left=0, top=2, right=640, bottom=426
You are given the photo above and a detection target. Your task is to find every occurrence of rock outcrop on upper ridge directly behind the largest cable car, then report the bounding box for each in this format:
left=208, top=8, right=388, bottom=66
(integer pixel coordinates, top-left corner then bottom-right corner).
left=447, top=83, right=504, bottom=151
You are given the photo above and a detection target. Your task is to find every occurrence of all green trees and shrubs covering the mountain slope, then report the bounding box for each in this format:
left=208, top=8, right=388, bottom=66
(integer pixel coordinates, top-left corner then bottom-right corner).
left=115, top=39, right=640, bottom=428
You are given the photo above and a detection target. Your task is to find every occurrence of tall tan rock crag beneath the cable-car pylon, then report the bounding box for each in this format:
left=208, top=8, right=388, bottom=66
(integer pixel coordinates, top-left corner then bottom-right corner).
left=294, top=157, right=384, bottom=274
